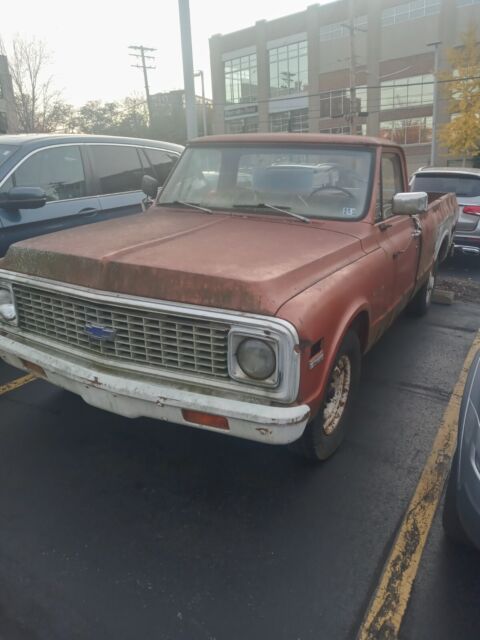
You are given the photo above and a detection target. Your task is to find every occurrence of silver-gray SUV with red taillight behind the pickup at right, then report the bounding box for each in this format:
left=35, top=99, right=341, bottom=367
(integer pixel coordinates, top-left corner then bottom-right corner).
left=410, top=167, right=480, bottom=255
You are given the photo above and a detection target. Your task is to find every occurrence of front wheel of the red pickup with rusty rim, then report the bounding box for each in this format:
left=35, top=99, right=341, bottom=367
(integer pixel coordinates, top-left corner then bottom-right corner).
left=290, top=331, right=361, bottom=462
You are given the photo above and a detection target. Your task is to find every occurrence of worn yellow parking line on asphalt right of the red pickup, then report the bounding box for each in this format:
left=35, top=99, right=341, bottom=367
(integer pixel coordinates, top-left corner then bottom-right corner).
left=357, top=331, right=480, bottom=640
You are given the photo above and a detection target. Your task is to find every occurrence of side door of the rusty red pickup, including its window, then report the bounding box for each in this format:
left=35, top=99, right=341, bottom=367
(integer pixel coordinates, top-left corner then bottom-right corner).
left=377, top=150, right=420, bottom=313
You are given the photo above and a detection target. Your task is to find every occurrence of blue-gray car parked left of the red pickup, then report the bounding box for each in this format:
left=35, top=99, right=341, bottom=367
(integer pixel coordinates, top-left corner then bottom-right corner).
left=0, top=134, right=183, bottom=257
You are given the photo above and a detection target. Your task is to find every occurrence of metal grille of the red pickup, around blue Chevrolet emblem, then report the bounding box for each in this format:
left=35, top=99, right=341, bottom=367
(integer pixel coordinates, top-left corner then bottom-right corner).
left=13, top=284, right=230, bottom=378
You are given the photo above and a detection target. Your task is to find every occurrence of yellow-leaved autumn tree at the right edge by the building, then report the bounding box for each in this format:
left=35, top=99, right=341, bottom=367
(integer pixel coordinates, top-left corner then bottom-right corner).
left=439, top=27, right=480, bottom=165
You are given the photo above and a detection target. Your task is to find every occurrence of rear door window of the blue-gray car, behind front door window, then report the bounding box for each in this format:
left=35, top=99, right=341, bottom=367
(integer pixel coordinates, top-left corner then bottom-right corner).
left=90, top=144, right=144, bottom=195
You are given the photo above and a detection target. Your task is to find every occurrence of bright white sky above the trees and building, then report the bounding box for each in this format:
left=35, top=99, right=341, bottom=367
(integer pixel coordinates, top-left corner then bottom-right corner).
left=0, top=0, right=329, bottom=107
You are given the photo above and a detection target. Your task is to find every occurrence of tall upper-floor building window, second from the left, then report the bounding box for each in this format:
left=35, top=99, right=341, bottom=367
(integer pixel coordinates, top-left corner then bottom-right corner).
left=268, top=40, right=308, bottom=96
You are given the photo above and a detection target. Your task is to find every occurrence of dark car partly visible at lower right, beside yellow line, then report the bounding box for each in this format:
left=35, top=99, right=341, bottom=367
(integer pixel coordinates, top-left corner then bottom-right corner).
left=443, top=351, right=480, bottom=550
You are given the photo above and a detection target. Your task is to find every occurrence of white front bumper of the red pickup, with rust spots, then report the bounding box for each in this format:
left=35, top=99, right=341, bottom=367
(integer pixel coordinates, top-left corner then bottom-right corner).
left=0, top=336, right=310, bottom=444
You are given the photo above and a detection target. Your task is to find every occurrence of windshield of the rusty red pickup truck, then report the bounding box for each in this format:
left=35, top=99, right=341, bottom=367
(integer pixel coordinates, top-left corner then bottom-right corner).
left=158, top=144, right=374, bottom=220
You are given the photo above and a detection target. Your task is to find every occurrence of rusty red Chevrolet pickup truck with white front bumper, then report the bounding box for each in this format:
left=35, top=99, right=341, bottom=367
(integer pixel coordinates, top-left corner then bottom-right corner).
left=0, top=133, right=458, bottom=460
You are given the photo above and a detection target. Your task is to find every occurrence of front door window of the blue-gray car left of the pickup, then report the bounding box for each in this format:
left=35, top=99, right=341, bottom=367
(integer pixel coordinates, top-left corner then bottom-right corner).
left=12, top=145, right=86, bottom=200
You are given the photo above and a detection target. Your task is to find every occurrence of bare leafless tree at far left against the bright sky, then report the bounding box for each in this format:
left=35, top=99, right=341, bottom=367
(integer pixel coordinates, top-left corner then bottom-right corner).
left=4, top=37, right=73, bottom=133
